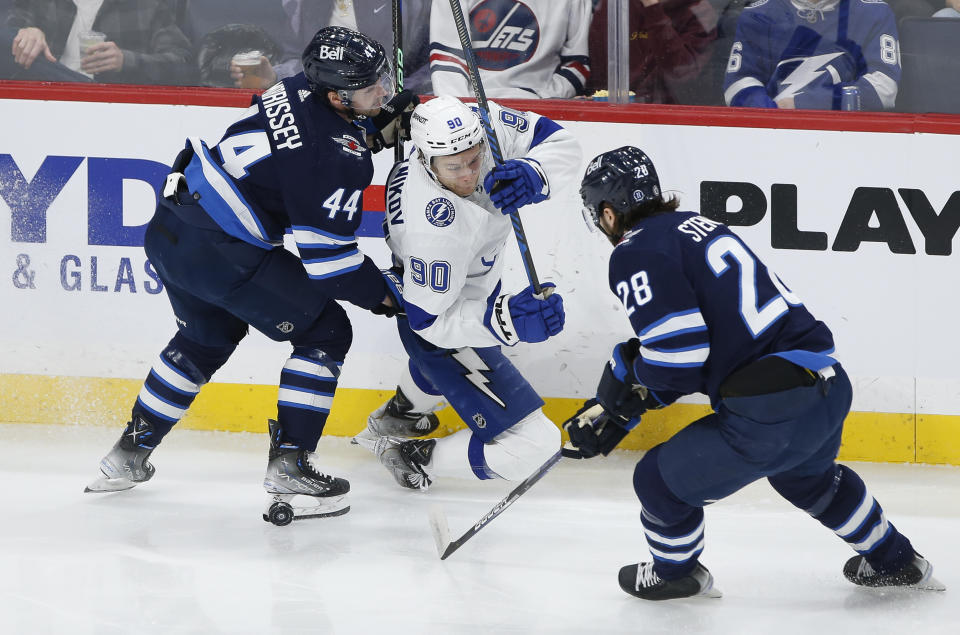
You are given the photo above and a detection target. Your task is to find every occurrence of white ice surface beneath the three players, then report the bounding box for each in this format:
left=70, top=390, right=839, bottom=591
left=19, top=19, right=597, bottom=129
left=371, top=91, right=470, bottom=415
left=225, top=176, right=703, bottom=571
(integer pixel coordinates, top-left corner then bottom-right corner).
left=0, top=424, right=960, bottom=635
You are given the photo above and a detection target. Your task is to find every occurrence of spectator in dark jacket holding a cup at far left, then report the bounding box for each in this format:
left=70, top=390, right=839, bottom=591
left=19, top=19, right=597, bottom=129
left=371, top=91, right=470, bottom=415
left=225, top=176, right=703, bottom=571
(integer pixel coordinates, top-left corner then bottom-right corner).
left=4, top=0, right=194, bottom=84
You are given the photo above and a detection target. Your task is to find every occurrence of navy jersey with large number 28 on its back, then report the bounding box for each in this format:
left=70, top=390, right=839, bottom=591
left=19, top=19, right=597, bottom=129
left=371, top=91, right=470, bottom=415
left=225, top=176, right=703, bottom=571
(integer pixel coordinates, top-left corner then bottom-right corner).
left=610, top=212, right=836, bottom=405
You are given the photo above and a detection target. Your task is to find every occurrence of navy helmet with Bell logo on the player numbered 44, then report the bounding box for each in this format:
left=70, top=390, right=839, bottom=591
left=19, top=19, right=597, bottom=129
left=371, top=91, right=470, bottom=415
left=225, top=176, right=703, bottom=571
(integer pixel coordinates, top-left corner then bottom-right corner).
left=301, top=26, right=394, bottom=106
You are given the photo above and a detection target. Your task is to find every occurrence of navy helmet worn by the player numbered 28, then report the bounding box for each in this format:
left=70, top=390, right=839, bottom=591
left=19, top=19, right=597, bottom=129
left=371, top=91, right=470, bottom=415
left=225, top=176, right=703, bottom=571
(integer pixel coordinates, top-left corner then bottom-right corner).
left=580, top=146, right=660, bottom=231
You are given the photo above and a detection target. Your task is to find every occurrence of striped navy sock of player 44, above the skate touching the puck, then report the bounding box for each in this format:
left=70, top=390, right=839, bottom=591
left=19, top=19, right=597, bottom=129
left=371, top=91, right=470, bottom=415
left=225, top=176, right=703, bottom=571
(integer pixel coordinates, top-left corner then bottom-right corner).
left=277, top=347, right=343, bottom=452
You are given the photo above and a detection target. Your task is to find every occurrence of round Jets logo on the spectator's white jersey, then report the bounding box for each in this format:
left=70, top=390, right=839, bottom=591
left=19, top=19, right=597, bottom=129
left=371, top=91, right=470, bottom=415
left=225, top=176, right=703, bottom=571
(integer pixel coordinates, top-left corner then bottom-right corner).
left=470, top=0, right=540, bottom=71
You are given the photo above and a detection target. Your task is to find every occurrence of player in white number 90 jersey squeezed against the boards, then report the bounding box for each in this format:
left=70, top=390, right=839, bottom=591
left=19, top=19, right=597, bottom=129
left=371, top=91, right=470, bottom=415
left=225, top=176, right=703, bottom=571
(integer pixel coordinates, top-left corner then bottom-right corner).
left=357, top=96, right=581, bottom=490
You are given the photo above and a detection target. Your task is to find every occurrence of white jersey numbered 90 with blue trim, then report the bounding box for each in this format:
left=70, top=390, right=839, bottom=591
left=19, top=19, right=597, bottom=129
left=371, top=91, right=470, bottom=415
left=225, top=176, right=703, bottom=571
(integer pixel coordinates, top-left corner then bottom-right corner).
left=384, top=102, right=581, bottom=349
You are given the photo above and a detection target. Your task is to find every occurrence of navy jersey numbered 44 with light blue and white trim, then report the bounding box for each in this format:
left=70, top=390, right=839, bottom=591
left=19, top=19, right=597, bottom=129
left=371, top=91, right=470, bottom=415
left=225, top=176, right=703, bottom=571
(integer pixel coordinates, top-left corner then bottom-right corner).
left=184, top=73, right=386, bottom=308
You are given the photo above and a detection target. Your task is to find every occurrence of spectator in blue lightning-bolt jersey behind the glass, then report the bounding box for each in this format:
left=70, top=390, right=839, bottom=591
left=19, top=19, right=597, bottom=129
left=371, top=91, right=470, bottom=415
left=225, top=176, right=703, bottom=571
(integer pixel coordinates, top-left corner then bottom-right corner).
left=723, top=0, right=900, bottom=110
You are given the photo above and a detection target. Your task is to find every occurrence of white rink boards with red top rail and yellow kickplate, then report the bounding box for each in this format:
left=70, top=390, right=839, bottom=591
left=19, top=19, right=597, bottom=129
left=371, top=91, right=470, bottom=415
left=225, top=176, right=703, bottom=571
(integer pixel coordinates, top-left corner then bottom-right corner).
left=0, top=86, right=960, bottom=464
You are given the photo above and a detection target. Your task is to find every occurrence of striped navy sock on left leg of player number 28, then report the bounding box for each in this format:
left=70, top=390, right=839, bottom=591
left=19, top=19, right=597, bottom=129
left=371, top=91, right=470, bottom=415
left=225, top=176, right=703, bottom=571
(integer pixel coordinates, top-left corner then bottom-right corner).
left=633, top=446, right=705, bottom=580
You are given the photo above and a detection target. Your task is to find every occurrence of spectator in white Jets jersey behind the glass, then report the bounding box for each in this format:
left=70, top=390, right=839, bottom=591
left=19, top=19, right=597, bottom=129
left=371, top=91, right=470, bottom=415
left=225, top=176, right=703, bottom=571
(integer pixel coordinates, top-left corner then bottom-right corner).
left=430, top=0, right=592, bottom=99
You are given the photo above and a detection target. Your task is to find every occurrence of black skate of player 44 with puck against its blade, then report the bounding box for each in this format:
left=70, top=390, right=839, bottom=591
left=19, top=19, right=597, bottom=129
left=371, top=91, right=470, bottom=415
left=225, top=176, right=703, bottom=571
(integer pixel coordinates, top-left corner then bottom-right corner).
left=263, top=419, right=350, bottom=526
